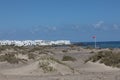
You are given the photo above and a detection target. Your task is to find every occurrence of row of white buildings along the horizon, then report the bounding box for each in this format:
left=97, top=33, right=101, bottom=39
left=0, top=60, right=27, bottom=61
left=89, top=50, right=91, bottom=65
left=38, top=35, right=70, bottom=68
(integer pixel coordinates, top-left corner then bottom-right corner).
left=0, top=40, right=71, bottom=46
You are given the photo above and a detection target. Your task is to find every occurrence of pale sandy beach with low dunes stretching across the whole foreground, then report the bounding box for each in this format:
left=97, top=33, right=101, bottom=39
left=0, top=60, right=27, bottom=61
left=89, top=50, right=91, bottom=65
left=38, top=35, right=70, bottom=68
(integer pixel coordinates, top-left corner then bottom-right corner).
left=0, top=46, right=120, bottom=80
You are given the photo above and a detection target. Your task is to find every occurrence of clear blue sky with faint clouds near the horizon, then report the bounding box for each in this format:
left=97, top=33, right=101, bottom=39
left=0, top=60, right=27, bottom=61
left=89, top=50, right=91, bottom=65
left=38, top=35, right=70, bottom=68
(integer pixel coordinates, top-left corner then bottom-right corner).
left=0, top=0, right=120, bottom=42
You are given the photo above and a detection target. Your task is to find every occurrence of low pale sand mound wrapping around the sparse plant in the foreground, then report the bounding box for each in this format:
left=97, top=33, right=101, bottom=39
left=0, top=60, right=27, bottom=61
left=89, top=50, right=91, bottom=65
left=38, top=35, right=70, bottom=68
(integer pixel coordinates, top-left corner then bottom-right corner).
left=1, top=61, right=72, bottom=75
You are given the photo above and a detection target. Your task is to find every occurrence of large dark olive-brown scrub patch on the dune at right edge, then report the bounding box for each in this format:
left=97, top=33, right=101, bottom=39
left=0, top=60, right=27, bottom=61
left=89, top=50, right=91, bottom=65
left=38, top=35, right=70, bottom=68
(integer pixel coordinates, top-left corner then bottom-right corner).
left=85, top=51, right=120, bottom=68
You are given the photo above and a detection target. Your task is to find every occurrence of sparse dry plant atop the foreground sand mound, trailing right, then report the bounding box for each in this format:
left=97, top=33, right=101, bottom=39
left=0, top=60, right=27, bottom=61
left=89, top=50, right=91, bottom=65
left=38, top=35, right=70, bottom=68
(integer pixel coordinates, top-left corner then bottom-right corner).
left=39, top=55, right=74, bottom=73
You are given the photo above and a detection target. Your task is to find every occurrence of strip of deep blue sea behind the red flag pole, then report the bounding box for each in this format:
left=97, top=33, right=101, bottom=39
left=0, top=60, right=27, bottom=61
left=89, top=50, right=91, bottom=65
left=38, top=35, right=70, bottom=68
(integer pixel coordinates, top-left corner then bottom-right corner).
left=72, top=41, right=120, bottom=48
